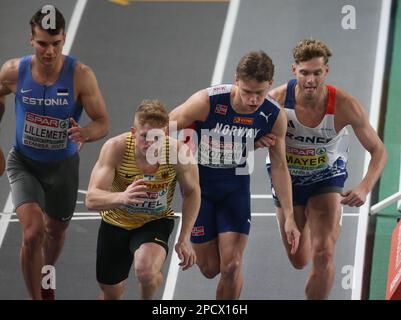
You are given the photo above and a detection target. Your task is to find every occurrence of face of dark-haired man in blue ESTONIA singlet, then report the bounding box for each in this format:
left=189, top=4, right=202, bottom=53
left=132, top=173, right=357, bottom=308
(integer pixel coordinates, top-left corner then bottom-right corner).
left=31, top=26, right=65, bottom=67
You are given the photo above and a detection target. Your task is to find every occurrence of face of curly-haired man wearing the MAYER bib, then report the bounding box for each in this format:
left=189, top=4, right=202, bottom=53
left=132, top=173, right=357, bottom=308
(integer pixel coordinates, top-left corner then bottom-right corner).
left=292, top=57, right=329, bottom=99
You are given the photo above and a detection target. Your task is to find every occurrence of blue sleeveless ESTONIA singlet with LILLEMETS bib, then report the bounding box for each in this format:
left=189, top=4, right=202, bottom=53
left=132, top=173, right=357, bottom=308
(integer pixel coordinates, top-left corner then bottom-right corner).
left=15, top=56, right=82, bottom=161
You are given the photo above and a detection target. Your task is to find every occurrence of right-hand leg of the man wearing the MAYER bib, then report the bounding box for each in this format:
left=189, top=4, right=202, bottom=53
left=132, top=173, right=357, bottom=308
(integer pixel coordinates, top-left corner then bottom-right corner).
left=305, top=192, right=342, bottom=299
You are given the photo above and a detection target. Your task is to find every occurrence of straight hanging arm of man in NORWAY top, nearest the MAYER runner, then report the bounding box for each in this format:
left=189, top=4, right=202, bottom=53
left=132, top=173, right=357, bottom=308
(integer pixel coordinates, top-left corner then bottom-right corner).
left=269, top=109, right=300, bottom=254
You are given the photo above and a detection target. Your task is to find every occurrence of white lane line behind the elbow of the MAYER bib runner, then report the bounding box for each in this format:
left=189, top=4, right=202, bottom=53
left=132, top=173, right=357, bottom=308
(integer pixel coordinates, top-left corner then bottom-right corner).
left=351, top=0, right=392, bottom=300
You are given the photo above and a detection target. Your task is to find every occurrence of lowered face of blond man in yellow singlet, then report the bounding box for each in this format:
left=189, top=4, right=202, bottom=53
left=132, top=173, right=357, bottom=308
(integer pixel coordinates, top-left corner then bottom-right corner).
left=131, top=121, right=166, bottom=156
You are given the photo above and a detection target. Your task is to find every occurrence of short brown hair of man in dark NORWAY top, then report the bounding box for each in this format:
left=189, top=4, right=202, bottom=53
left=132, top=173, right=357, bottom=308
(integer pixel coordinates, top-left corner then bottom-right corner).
left=236, top=50, right=274, bottom=82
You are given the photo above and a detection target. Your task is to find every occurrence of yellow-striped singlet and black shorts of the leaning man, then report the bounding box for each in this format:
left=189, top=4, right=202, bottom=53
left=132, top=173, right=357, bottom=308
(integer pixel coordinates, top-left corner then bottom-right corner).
left=96, top=133, right=176, bottom=285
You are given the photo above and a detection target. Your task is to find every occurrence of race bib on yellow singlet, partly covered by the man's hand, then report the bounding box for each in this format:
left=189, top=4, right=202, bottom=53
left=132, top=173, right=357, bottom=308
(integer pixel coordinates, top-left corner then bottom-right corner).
left=121, top=188, right=168, bottom=216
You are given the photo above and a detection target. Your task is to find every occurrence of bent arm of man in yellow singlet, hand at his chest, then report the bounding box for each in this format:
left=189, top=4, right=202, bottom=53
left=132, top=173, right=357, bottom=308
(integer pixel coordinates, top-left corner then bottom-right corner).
left=85, top=136, right=145, bottom=210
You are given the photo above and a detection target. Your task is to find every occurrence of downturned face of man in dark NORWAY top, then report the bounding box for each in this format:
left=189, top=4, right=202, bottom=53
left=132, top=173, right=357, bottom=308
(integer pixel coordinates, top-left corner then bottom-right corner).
left=235, top=78, right=272, bottom=113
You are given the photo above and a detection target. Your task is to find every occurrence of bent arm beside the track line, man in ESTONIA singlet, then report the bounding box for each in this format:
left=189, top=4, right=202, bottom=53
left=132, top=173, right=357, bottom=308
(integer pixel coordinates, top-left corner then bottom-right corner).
left=68, top=62, right=109, bottom=143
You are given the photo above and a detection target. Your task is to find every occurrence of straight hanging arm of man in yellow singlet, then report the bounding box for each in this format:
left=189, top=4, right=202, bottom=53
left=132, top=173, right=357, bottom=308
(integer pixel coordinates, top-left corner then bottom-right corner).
left=175, top=142, right=201, bottom=270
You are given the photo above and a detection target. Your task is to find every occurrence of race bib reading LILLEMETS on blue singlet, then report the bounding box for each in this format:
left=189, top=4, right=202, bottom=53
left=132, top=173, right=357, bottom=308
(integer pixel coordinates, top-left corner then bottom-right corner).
left=22, top=112, right=68, bottom=150
